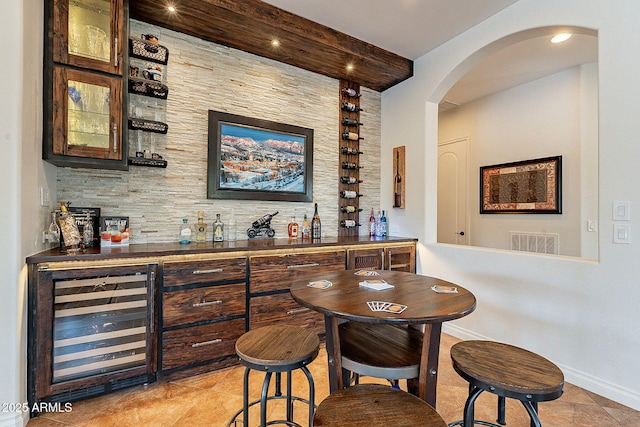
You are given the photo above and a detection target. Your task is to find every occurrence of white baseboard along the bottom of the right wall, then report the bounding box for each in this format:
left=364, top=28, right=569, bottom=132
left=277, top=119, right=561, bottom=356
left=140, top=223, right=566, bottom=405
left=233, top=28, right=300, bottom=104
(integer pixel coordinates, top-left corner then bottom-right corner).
left=442, top=323, right=640, bottom=411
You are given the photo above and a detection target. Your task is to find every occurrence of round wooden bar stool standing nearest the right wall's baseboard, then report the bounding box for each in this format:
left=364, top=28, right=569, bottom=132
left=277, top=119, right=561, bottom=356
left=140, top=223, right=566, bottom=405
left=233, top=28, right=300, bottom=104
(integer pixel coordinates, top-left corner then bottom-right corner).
left=449, top=341, right=564, bottom=427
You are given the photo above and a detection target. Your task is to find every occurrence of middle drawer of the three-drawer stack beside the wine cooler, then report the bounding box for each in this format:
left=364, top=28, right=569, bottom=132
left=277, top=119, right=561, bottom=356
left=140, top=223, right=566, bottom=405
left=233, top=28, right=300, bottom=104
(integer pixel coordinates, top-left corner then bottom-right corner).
left=162, top=283, right=246, bottom=327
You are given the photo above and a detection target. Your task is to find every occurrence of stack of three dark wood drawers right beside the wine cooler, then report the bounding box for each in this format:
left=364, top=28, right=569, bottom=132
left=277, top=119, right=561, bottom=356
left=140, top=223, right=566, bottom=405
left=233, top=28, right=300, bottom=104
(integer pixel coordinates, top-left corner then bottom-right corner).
left=160, top=257, right=247, bottom=376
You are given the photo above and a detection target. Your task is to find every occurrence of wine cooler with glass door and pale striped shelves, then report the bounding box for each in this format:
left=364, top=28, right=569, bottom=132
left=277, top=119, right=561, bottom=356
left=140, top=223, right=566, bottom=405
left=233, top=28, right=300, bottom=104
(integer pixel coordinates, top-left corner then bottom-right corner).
left=28, top=264, right=157, bottom=412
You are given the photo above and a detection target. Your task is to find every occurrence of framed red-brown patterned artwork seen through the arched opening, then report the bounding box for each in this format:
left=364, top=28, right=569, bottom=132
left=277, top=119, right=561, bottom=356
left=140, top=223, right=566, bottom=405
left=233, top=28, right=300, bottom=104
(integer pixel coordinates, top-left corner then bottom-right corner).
left=480, top=156, right=562, bottom=214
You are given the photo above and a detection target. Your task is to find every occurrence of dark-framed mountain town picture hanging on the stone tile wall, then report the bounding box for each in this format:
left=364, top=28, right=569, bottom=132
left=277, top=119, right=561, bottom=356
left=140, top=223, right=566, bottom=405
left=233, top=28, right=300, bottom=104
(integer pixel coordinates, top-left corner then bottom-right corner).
left=207, top=110, right=313, bottom=202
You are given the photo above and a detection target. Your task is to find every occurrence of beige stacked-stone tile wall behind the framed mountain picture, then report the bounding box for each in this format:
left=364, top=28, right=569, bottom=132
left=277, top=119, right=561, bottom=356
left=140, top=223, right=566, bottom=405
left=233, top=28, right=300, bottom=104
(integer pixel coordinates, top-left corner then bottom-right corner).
left=57, top=21, right=380, bottom=243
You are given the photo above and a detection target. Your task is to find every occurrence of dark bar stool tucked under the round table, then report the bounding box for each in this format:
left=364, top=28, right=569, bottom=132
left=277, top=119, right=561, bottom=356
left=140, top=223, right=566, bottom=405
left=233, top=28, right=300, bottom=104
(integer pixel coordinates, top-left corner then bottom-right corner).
left=339, top=322, right=423, bottom=389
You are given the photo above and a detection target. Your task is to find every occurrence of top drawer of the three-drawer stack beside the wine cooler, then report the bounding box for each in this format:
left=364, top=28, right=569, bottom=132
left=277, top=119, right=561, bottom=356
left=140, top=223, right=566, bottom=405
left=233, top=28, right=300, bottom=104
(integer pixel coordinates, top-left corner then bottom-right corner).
left=163, top=257, right=247, bottom=287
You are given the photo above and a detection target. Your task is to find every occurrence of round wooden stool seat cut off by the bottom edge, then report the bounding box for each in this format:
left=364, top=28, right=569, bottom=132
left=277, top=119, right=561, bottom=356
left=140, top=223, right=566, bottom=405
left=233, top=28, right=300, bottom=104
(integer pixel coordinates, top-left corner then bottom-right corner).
left=313, top=384, right=447, bottom=427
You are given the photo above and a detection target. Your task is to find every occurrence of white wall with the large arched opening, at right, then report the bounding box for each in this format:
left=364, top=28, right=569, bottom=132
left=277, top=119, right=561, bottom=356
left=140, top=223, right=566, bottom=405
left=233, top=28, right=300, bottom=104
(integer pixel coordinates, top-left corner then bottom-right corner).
left=381, top=0, right=640, bottom=409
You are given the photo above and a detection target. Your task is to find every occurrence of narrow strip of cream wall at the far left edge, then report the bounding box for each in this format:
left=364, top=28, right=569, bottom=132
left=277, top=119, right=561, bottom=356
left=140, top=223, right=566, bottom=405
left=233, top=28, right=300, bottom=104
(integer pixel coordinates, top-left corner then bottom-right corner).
left=0, top=0, right=46, bottom=426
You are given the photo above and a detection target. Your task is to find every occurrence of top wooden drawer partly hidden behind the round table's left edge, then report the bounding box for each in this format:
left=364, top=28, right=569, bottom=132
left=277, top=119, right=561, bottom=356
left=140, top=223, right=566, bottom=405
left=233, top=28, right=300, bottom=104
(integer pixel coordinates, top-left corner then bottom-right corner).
left=249, top=250, right=346, bottom=293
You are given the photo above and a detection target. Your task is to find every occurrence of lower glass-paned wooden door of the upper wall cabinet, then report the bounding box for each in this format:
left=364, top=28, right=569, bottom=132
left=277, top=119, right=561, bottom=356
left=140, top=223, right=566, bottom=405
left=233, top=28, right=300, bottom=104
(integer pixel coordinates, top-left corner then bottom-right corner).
left=44, top=67, right=126, bottom=164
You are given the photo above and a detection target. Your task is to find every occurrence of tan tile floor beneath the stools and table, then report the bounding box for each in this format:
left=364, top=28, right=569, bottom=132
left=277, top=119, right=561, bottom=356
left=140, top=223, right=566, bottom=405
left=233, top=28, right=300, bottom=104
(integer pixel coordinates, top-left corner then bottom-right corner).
left=27, top=335, right=640, bottom=427
